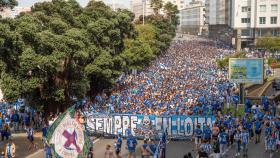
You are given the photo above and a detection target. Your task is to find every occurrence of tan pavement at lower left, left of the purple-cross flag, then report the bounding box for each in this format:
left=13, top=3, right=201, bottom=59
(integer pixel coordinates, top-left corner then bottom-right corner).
left=0, top=133, right=43, bottom=158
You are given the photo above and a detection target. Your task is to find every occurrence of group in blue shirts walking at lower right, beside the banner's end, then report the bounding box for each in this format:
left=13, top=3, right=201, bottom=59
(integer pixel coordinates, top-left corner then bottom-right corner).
left=194, top=102, right=280, bottom=158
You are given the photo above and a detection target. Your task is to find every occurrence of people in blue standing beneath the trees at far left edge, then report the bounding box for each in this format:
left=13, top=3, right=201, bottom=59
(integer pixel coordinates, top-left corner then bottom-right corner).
left=0, top=103, right=49, bottom=157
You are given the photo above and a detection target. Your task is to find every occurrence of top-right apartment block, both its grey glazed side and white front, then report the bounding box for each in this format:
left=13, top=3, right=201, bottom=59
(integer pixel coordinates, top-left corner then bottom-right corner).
left=205, top=0, right=280, bottom=50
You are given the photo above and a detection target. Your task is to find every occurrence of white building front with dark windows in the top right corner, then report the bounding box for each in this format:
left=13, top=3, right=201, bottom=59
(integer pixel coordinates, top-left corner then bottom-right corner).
left=231, top=0, right=280, bottom=47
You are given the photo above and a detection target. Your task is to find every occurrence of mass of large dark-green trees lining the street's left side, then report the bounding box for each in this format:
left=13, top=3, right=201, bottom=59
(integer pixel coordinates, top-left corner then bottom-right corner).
left=0, top=0, right=176, bottom=111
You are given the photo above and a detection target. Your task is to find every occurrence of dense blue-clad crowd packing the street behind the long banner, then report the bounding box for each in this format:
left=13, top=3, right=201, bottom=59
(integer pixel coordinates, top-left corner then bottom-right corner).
left=88, top=39, right=234, bottom=115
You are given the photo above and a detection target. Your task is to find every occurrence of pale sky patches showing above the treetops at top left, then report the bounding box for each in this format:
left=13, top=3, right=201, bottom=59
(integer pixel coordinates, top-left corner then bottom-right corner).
left=18, top=0, right=130, bottom=8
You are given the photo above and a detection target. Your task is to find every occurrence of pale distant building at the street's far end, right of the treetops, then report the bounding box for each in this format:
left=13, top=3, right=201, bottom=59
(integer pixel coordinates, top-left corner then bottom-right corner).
left=179, top=2, right=207, bottom=35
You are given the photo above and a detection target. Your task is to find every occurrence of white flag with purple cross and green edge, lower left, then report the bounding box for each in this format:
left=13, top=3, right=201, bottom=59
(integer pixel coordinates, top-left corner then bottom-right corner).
left=47, top=108, right=91, bottom=158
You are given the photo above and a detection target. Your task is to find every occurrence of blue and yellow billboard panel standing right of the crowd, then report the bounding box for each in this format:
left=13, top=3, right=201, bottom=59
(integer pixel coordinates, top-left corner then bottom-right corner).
left=229, top=58, right=264, bottom=84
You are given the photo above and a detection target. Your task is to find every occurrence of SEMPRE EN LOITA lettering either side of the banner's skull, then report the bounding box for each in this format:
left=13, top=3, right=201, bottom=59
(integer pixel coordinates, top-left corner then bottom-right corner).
left=87, top=113, right=215, bottom=137
